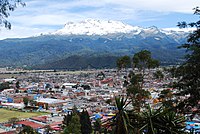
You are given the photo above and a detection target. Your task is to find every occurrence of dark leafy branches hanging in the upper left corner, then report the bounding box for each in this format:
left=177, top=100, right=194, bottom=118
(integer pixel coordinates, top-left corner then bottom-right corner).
left=0, top=0, right=25, bottom=29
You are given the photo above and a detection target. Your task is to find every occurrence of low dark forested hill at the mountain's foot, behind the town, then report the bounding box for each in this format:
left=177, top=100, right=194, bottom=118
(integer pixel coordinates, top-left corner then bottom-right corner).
left=33, top=55, right=118, bottom=70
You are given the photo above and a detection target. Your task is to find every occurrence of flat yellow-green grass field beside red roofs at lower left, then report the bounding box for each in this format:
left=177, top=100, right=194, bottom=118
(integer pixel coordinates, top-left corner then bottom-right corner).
left=0, top=108, right=48, bottom=122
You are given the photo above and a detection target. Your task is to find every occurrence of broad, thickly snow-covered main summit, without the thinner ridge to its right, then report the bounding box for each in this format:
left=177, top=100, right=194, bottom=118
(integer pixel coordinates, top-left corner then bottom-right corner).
left=53, top=19, right=140, bottom=35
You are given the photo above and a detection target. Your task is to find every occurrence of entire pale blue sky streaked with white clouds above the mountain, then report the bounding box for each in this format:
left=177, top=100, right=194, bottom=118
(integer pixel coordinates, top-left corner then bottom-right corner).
left=0, top=0, right=200, bottom=39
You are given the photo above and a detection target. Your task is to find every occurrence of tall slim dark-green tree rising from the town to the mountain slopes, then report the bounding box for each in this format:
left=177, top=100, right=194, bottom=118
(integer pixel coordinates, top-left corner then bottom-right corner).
left=127, top=50, right=159, bottom=111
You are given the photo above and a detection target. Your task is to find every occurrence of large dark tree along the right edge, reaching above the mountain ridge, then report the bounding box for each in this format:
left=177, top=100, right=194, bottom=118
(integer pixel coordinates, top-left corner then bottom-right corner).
left=174, top=7, right=200, bottom=111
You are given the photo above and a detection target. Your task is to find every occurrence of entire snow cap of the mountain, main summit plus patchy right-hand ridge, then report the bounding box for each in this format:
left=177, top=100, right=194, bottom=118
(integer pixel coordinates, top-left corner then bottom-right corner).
left=51, top=19, right=190, bottom=37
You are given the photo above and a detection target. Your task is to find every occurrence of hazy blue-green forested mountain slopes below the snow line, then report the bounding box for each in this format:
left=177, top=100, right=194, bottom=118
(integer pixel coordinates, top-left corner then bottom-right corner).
left=0, top=35, right=185, bottom=70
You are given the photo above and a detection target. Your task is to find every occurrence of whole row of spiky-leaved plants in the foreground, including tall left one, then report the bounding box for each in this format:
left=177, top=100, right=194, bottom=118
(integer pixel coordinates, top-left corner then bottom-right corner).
left=102, top=97, right=185, bottom=134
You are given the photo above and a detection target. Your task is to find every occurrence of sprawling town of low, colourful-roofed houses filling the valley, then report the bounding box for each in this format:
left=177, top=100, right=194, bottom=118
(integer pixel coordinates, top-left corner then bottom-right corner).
left=0, top=69, right=198, bottom=133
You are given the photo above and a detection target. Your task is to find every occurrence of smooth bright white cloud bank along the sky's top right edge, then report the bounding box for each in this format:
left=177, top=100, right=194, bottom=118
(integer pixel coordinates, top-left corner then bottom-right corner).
left=105, top=0, right=200, bottom=13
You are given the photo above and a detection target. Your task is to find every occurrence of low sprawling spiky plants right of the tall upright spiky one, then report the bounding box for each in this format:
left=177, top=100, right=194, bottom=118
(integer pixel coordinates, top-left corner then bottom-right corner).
left=140, top=105, right=185, bottom=134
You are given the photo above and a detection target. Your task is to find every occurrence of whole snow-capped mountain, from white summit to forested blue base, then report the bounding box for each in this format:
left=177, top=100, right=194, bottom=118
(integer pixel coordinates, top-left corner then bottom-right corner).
left=0, top=19, right=189, bottom=69
